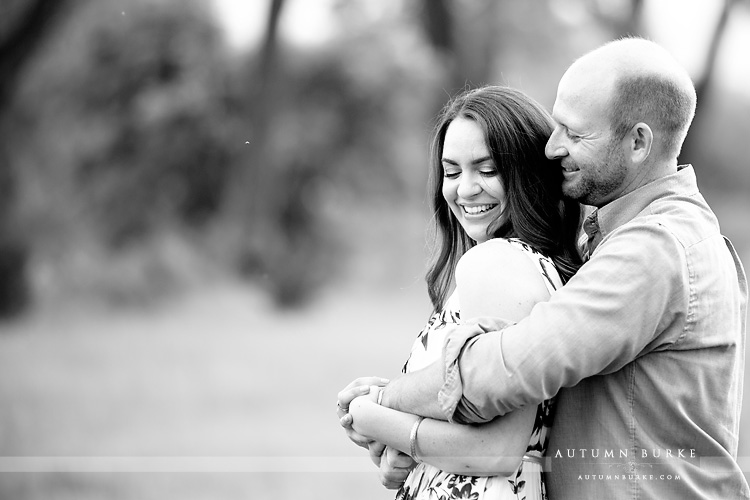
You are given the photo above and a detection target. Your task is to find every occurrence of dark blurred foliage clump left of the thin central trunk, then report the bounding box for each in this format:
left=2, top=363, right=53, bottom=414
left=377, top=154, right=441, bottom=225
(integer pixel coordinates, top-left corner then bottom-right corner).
left=75, top=3, right=229, bottom=247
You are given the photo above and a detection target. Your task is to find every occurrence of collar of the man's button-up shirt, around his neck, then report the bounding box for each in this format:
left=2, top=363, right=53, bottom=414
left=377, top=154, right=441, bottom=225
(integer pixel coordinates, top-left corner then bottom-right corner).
left=592, top=165, right=698, bottom=251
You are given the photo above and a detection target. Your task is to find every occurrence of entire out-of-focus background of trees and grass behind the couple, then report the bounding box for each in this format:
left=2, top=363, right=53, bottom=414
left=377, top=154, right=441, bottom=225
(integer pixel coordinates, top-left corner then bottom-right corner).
left=0, top=0, right=750, bottom=500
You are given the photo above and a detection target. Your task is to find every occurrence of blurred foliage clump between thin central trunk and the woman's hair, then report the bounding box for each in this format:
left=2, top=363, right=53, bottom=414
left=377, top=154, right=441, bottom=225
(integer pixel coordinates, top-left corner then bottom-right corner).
left=220, top=2, right=446, bottom=305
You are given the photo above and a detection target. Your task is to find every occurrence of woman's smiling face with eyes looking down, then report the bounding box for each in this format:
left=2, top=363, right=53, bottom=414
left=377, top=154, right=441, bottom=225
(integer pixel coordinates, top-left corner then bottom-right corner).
left=441, top=118, right=506, bottom=243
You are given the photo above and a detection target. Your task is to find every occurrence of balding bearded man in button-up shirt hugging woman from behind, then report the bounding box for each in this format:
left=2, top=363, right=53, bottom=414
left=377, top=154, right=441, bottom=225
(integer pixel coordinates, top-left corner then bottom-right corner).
left=356, top=39, right=750, bottom=499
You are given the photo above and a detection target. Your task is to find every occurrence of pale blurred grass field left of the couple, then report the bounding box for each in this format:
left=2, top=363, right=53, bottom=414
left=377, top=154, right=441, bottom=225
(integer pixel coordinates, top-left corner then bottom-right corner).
left=0, top=285, right=428, bottom=500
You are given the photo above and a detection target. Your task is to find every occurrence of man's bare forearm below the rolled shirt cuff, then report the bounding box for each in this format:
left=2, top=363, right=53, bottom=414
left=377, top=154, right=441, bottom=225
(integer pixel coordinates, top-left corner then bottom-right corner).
left=381, top=361, right=447, bottom=420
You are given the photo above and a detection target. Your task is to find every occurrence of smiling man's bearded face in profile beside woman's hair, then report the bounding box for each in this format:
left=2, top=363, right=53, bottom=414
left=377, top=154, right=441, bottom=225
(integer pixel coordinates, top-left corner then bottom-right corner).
left=545, top=68, right=629, bottom=207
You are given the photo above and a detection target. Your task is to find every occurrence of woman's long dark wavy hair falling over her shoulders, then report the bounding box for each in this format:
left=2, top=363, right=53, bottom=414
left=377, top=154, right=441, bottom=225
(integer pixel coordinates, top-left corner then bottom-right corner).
left=426, top=86, right=581, bottom=311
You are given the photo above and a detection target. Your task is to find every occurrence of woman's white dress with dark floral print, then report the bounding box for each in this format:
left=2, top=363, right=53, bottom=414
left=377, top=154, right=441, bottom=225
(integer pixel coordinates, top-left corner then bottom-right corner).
left=396, top=238, right=562, bottom=500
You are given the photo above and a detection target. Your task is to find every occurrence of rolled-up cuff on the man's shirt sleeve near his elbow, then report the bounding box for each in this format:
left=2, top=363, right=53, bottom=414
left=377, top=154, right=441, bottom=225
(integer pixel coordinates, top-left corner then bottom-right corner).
left=438, top=318, right=513, bottom=423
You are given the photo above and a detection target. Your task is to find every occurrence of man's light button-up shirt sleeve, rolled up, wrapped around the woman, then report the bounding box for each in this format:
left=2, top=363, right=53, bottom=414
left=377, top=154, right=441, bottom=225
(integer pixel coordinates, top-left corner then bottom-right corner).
left=439, top=222, right=689, bottom=423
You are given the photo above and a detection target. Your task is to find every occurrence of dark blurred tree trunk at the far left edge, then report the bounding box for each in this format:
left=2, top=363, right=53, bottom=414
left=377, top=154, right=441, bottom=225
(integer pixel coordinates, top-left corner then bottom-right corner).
left=0, top=0, right=70, bottom=318
